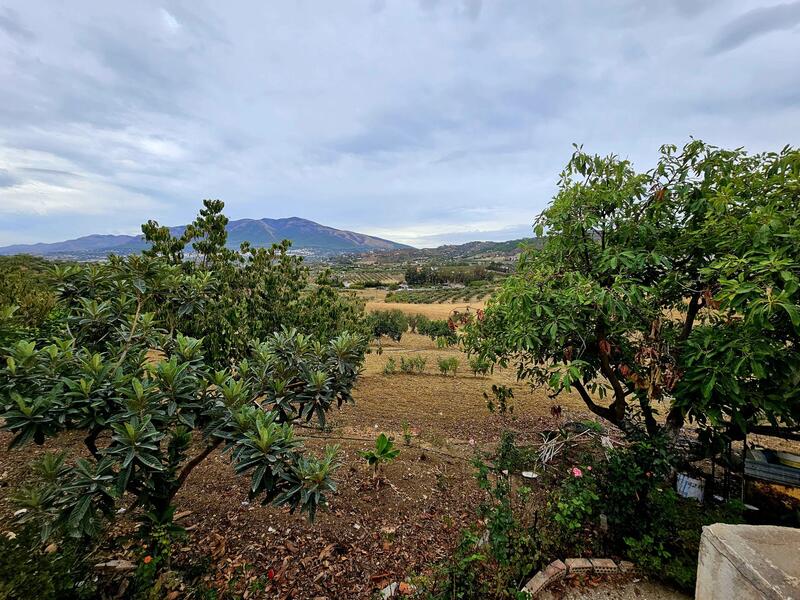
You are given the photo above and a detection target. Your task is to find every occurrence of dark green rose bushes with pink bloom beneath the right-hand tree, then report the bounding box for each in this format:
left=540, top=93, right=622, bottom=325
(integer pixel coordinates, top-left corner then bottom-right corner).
left=422, top=433, right=742, bottom=600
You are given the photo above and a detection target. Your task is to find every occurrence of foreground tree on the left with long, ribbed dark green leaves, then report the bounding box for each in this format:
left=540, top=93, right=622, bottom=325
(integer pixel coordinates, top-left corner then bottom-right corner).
left=0, top=202, right=367, bottom=552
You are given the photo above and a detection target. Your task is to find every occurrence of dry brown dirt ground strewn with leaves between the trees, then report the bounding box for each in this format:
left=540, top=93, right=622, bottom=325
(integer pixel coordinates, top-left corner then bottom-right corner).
left=0, top=333, right=600, bottom=599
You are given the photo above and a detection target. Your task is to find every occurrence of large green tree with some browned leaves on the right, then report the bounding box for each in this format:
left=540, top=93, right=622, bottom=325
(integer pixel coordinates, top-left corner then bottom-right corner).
left=465, top=141, right=800, bottom=436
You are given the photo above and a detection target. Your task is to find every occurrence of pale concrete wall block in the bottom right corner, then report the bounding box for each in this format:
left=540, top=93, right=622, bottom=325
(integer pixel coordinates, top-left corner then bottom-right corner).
left=695, top=523, right=800, bottom=600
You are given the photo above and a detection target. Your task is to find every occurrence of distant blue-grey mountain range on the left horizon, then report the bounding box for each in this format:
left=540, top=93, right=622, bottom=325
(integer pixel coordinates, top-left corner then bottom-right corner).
left=0, top=217, right=410, bottom=260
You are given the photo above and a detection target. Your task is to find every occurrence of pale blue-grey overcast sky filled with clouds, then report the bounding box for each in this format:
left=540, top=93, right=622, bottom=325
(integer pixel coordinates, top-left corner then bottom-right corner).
left=0, top=0, right=800, bottom=246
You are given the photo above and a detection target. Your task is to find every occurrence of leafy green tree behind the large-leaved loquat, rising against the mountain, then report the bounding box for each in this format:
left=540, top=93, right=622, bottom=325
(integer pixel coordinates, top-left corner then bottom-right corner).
left=142, top=200, right=367, bottom=365
